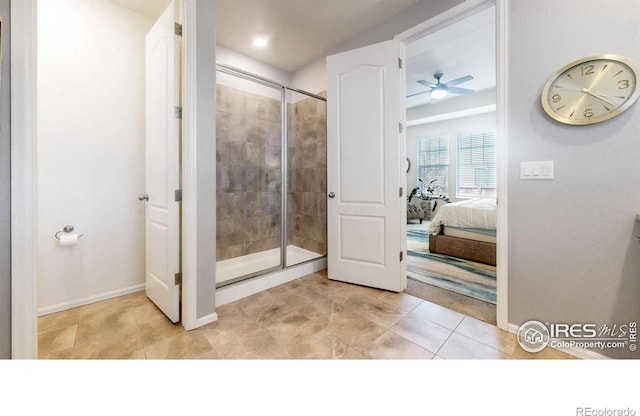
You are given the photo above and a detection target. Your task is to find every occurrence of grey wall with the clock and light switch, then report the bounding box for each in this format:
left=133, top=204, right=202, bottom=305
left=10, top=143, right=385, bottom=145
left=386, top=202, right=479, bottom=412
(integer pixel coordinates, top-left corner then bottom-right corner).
left=508, top=0, right=640, bottom=358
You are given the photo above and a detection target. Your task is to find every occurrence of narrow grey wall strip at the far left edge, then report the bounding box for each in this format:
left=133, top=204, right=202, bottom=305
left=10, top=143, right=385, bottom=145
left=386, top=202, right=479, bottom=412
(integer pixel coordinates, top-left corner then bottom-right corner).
left=0, top=0, right=11, bottom=359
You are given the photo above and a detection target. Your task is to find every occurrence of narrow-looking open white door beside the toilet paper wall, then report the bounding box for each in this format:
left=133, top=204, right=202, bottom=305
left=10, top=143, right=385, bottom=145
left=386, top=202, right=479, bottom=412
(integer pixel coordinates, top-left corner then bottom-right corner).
left=145, top=1, right=180, bottom=322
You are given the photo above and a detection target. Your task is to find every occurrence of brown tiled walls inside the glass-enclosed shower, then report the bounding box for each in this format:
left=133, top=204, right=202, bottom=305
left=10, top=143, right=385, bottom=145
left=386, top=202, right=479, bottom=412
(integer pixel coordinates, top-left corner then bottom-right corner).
left=216, top=84, right=327, bottom=261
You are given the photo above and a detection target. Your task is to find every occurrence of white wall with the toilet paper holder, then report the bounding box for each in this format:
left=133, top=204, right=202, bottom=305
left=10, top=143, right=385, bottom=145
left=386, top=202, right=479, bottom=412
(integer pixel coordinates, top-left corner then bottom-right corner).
left=38, top=0, right=153, bottom=312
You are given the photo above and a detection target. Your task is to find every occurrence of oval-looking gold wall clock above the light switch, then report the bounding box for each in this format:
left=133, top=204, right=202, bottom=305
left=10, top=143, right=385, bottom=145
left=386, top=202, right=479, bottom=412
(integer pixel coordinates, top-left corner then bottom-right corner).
left=540, top=55, right=640, bottom=126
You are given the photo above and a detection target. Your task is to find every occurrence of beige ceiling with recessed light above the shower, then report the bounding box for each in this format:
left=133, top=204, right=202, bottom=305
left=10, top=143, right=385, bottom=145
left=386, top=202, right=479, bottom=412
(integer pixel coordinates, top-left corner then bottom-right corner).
left=216, top=0, right=417, bottom=72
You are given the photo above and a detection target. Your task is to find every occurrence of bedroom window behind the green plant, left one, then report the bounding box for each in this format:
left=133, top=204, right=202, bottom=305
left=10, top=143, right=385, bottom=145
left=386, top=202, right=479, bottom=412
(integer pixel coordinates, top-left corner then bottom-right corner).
left=418, top=136, right=449, bottom=195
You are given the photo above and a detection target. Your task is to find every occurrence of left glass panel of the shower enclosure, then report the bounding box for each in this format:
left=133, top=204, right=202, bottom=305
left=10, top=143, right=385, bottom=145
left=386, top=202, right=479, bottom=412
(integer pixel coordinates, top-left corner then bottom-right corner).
left=216, top=70, right=283, bottom=284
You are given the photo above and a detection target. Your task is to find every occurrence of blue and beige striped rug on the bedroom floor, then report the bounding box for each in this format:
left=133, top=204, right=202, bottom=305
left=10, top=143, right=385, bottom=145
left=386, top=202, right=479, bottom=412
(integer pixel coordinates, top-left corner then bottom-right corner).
left=407, top=224, right=496, bottom=304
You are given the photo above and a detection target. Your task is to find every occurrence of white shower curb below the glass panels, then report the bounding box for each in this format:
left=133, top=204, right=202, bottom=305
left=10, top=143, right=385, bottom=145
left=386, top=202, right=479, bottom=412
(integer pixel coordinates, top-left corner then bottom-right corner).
left=216, top=258, right=327, bottom=307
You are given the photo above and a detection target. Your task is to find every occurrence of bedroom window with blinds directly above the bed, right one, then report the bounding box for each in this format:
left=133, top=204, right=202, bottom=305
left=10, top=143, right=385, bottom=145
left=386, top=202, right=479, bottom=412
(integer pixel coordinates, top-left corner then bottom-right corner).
left=456, top=130, right=497, bottom=198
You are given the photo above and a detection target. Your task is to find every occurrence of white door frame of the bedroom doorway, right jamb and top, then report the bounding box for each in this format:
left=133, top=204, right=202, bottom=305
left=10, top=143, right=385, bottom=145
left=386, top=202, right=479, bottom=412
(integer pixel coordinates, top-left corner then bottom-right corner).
left=395, top=0, right=509, bottom=331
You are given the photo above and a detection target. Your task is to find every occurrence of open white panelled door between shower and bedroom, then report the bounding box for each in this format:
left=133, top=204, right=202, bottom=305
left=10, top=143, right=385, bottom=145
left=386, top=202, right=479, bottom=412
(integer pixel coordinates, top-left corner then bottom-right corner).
left=327, top=40, right=407, bottom=292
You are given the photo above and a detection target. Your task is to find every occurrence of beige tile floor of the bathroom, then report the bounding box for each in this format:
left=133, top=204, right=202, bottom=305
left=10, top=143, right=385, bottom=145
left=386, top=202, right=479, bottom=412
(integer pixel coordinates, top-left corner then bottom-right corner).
left=38, top=272, right=573, bottom=359
